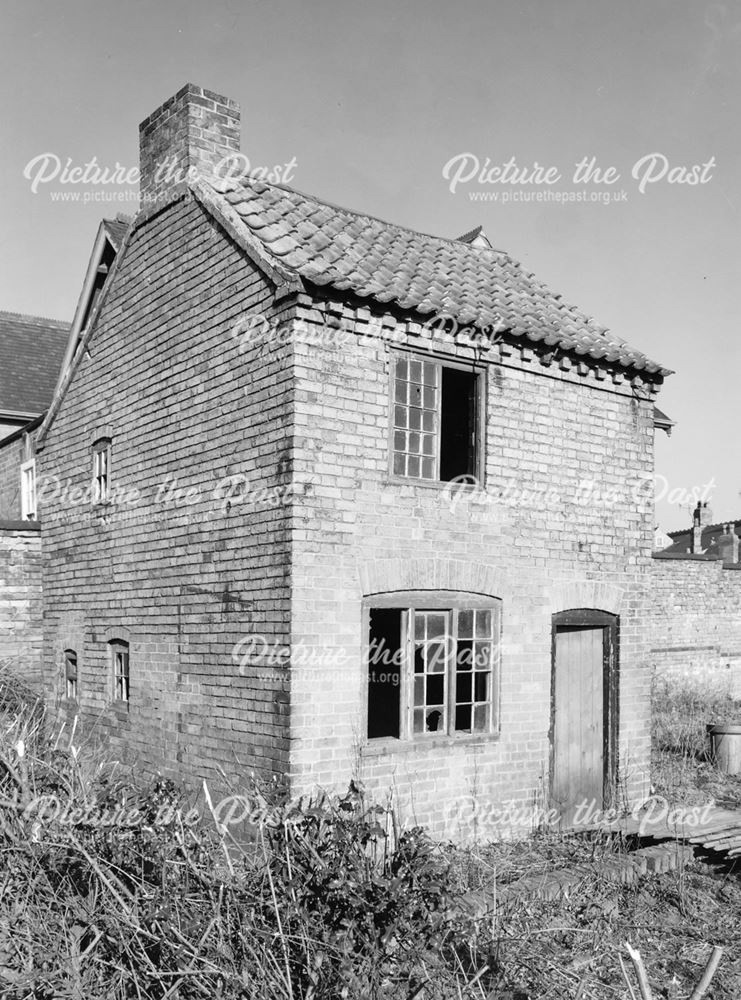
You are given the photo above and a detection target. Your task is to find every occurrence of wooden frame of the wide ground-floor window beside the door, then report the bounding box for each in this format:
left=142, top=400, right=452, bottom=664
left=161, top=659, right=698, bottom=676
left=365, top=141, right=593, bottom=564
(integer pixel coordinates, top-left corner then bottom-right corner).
left=363, top=590, right=503, bottom=746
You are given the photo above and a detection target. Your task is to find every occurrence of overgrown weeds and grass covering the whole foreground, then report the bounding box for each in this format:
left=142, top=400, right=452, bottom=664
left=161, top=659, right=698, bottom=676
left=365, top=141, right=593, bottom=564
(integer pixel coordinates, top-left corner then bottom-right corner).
left=0, top=664, right=741, bottom=1000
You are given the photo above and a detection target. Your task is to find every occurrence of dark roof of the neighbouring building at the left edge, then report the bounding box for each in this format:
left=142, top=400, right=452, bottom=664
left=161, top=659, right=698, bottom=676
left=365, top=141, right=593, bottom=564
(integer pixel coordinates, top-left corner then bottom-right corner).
left=0, top=312, right=69, bottom=417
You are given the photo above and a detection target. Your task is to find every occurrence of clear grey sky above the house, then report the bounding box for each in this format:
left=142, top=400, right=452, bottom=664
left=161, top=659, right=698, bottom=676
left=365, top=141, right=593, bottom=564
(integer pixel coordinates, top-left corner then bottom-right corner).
left=0, top=0, right=741, bottom=530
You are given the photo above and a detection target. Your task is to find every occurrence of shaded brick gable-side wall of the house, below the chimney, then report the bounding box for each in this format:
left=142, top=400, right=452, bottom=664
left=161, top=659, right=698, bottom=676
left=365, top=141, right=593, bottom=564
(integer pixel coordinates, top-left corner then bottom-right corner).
left=39, top=195, right=291, bottom=782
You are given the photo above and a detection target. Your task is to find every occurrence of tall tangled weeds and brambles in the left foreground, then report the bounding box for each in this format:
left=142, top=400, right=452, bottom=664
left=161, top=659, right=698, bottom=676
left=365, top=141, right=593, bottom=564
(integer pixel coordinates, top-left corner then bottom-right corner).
left=0, top=668, right=492, bottom=1000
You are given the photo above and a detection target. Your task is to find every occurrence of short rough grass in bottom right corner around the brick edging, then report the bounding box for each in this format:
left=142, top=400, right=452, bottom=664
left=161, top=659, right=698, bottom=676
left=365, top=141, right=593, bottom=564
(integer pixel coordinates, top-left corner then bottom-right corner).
left=450, top=835, right=741, bottom=1000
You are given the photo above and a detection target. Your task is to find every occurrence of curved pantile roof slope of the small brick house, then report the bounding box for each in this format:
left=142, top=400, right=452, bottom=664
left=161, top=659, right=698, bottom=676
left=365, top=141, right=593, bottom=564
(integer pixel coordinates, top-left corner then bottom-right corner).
left=212, top=178, right=671, bottom=375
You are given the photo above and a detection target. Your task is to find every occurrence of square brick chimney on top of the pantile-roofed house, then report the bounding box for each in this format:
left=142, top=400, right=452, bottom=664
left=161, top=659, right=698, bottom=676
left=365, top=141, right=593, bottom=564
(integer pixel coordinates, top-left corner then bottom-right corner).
left=139, top=83, right=240, bottom=208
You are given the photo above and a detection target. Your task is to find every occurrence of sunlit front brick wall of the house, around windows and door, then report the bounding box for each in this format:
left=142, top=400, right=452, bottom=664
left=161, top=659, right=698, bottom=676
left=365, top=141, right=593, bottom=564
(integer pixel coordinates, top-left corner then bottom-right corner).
left=291, top=305, right=653, bottom=836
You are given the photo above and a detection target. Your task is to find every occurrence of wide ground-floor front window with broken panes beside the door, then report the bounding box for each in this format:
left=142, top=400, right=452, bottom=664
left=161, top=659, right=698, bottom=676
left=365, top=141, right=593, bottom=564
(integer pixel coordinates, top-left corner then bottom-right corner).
left=368, top=594, right=500, bottom=739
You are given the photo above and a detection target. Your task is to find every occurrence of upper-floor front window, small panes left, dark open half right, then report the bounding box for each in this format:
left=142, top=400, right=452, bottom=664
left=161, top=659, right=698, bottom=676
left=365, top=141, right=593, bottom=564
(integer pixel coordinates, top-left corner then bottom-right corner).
left=392, top=356, right=482, bottom=482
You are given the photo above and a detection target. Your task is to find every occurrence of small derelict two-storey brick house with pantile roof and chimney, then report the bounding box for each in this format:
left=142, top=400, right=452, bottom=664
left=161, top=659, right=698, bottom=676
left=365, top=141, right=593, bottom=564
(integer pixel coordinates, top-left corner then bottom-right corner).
left=31, top=85, right=667, bottom=837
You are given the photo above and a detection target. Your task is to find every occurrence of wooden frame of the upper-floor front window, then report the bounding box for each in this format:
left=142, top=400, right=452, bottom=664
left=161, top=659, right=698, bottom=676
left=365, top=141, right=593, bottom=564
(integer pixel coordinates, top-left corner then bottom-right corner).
left=388, top=349, right=486, bottom=487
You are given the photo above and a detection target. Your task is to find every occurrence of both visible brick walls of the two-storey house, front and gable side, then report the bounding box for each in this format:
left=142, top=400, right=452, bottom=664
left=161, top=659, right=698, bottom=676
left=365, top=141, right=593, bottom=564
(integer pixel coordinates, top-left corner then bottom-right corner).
left=33, top=191, right=664, bottom=836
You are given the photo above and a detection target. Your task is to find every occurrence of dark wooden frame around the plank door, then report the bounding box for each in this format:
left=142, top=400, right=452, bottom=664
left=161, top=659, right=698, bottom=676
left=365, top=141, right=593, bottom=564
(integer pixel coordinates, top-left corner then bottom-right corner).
left=548, top=608, right=620, bottom=809
